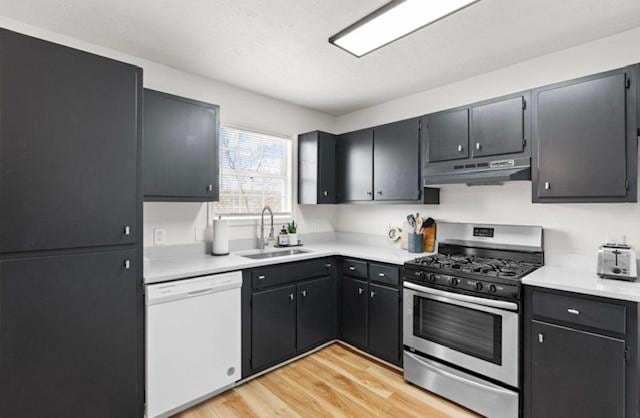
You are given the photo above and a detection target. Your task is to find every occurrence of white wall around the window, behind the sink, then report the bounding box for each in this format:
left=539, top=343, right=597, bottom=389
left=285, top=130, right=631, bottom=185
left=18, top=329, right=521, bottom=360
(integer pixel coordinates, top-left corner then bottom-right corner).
left=0, top=17, right=335, bottom=246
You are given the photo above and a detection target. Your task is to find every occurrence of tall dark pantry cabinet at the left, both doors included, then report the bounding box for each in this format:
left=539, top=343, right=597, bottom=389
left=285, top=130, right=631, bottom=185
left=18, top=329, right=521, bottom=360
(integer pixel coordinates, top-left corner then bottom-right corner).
left=0, top=30, right=144, bottom=418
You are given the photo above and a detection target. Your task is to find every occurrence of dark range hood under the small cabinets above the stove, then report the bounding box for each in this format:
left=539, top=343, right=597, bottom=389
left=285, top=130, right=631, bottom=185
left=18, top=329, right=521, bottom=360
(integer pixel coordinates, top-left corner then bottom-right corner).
left=424, top=158, right=531, bottom=186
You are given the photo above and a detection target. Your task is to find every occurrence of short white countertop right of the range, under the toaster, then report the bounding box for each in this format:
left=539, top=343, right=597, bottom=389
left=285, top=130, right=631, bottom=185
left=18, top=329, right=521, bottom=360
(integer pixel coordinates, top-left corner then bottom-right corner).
left=522, top=255, right=640, bottom=302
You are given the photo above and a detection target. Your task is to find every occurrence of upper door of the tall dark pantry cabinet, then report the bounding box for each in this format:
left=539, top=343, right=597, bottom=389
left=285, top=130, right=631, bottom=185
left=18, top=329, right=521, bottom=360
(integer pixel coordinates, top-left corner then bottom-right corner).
left=0, top=30, right=142, bottom=252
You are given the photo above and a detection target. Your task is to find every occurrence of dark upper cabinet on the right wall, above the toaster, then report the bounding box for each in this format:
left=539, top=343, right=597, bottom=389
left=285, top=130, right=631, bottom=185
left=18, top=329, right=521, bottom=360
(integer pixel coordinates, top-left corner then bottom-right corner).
left=532, top=66, right=638, bottom=202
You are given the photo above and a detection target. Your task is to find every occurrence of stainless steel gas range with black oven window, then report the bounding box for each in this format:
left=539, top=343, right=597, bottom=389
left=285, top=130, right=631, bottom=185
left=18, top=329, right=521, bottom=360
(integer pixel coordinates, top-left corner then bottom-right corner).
left=403, top=222, right=544, bottom=418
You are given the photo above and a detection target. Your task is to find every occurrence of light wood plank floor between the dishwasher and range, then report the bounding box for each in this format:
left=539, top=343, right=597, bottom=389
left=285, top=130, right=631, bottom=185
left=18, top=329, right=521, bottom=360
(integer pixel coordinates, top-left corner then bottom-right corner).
left=177, top=343, right=477, bottom=418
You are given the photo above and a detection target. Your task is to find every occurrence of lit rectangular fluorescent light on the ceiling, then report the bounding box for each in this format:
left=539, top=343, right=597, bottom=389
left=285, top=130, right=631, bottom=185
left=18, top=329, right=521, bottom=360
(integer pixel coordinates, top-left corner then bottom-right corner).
left=329, top=0, right=479, bottom=57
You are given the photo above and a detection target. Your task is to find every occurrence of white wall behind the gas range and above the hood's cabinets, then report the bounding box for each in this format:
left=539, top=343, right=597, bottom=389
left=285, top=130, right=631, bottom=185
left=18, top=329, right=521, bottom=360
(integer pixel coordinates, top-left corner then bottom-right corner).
left=336, top=28, right=640, bottom=255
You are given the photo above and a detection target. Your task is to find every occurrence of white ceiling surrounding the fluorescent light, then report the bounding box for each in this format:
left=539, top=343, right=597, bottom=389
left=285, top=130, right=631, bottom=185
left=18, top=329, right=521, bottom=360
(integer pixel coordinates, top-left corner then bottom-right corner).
left=0, top=0, right=640, bottom=115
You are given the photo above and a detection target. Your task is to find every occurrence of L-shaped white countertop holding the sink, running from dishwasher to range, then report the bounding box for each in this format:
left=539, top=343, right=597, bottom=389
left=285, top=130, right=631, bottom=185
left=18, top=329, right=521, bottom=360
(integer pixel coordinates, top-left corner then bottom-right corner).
left=144, top=240, right=427, bottom=284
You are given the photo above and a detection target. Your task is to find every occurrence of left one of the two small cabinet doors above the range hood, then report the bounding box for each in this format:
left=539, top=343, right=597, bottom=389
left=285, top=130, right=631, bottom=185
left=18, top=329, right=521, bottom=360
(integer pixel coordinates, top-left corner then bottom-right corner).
left=423, top=108, right=469, bottom=162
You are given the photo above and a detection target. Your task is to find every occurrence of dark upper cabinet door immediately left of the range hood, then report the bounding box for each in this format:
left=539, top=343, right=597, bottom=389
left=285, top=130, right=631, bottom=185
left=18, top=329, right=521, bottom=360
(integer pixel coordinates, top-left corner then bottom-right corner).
left=373, top=119, right=420, bottom=200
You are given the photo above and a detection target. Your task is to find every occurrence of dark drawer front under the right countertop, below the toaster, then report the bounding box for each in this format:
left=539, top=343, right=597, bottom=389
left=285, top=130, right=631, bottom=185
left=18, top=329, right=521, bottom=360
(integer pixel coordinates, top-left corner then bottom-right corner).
left=533, top=291, right=626, bottom=334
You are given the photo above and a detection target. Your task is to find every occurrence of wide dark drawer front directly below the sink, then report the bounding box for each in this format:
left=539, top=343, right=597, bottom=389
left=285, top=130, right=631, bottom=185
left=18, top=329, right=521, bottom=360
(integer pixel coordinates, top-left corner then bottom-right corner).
left=251, top=258, right=335, bottom=290
